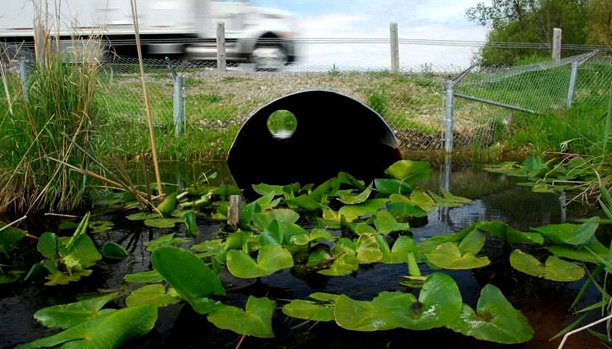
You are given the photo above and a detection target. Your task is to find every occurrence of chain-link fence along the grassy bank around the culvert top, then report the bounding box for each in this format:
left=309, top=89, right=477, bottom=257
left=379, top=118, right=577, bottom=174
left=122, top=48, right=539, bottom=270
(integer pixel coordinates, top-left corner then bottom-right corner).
left=5, top=41, right=612, bottom=153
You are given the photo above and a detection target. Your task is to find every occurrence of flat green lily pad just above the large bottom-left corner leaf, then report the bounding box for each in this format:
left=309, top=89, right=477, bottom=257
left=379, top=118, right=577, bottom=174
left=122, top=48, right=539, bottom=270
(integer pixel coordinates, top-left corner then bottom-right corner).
left=34, top=292, right=119, bottom=329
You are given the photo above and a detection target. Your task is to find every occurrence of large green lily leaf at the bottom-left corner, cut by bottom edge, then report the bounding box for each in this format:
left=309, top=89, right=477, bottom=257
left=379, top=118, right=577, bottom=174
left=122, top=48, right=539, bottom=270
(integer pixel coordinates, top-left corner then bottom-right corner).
left=17, top=306, right=157, bottom=349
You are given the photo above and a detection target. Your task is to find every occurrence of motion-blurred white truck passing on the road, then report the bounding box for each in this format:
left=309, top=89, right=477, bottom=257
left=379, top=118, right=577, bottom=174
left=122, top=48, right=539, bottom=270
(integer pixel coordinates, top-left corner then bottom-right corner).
left=0, top=0, right=297, bottom=70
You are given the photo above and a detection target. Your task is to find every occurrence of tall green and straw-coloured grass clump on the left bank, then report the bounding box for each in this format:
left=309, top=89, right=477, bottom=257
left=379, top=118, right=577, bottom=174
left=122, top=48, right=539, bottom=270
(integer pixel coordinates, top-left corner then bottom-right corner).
left=0, top=25, right=101, bottom=212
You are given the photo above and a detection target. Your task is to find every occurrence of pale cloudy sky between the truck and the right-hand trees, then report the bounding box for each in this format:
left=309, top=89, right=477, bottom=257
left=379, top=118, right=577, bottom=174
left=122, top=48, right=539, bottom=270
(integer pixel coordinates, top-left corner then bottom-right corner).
left=253, top=0, right=487, bottom=69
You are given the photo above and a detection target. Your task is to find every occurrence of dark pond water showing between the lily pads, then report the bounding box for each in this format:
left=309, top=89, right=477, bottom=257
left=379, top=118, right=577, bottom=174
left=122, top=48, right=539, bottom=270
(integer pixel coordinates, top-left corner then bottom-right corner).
left=0, top=163, right=601, bottom=348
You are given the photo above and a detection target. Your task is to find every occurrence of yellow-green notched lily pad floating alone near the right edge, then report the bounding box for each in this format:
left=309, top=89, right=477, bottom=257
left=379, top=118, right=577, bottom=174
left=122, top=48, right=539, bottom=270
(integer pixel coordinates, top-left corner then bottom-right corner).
left=510, top=250, right=584, bottom=282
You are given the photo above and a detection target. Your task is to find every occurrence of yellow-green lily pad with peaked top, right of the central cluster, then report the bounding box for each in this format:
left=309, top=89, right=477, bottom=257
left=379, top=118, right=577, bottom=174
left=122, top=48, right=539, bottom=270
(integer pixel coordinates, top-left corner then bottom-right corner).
left=427, top=242, right=491, bottom=270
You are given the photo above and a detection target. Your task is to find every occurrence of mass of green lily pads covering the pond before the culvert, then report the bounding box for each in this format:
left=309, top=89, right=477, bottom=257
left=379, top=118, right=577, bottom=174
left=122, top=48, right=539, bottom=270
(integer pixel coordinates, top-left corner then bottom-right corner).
left=0, top=160, right=608, bottom=348
